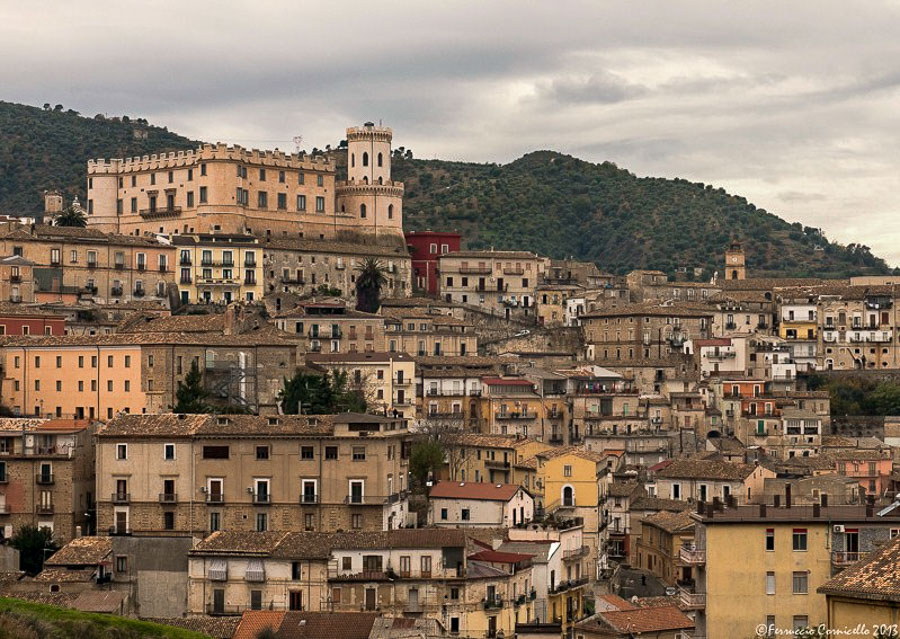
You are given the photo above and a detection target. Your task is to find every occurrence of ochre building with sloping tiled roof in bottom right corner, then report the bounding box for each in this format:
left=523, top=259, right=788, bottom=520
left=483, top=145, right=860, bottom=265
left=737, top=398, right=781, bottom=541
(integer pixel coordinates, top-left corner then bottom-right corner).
left=818, top=536, right=900, bottom=637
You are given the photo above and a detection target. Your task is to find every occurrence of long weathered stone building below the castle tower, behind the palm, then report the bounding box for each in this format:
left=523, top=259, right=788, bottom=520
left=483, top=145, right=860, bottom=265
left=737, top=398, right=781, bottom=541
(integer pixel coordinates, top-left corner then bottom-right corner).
left=264, top=238, right=412, bottom=312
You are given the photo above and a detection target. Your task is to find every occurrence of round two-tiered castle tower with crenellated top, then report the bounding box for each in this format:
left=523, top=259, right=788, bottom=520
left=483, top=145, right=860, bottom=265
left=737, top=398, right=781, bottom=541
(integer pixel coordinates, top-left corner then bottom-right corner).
left=335, top=122, right=403, bottom=237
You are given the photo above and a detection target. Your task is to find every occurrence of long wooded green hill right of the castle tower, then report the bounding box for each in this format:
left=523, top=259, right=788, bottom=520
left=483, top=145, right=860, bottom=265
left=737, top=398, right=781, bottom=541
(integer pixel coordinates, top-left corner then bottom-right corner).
left=392, top=151, right=888, bottom=277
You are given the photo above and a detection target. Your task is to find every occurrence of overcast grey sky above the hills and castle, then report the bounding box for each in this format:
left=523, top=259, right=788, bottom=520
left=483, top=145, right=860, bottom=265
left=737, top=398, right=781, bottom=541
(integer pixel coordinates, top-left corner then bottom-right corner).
left=0, top=0, right=900, bottom=265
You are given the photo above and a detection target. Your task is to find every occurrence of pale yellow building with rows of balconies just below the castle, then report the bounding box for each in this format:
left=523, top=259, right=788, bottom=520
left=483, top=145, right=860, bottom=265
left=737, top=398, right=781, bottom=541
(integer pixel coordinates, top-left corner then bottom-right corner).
left=172, top=234, right=263, bottom=304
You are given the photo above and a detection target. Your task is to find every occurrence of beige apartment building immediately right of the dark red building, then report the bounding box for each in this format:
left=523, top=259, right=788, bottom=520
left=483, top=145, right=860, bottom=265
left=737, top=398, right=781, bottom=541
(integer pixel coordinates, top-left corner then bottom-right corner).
left=438, top=249, right=548, bottom=317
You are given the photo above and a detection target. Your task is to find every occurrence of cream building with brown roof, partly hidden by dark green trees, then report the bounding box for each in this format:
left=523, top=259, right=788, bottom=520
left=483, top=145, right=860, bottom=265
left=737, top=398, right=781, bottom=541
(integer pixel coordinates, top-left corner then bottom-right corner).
left=306, top=352, right=416, bottom=419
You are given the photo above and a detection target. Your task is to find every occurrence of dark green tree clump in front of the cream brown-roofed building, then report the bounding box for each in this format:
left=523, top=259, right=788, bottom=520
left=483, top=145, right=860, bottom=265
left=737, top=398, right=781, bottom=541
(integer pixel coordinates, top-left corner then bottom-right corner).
left=278, top=370, right=369, bottom=415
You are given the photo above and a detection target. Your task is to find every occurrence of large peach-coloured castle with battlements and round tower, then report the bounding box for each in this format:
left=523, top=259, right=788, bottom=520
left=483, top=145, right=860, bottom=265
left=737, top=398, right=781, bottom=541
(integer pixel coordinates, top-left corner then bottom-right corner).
left=87, top=123, right=403, bottom=239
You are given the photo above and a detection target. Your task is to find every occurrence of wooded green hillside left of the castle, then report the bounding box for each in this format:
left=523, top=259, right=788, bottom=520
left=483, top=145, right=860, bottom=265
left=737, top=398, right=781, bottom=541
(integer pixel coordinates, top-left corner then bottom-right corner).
left=0, top=102, right=197, bottom=215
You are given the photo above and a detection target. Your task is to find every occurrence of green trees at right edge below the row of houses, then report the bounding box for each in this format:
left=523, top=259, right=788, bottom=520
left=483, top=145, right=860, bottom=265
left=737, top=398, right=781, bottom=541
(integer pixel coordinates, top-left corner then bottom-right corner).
left=808, top=375, right=900, bottom=415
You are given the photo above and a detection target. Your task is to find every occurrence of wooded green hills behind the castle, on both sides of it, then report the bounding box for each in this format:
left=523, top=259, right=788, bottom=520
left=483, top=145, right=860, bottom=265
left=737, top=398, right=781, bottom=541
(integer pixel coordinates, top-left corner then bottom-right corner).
left=0, top=102, right=888, bottom=277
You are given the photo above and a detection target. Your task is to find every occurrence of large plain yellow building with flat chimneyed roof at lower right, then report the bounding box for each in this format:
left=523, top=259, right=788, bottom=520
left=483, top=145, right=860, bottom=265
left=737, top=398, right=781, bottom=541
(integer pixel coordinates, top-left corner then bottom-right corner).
left=680, top=502, right=900, bottom=637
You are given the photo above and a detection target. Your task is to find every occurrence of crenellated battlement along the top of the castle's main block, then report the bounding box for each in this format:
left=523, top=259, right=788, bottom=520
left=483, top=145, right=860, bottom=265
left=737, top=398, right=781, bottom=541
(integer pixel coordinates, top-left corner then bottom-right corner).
left=87, top=142, right=335, bottom=175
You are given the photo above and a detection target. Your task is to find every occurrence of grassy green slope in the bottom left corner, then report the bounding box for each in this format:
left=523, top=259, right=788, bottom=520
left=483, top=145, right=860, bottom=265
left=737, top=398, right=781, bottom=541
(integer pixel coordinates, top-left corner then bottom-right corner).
left=0, top=597, right=208, bottom=639
